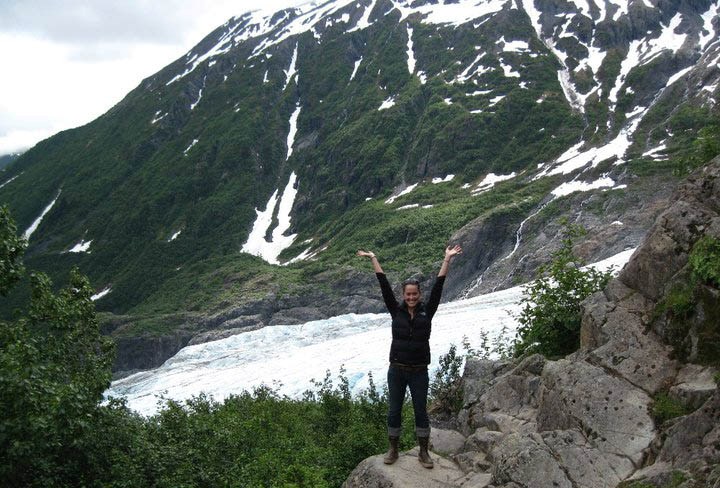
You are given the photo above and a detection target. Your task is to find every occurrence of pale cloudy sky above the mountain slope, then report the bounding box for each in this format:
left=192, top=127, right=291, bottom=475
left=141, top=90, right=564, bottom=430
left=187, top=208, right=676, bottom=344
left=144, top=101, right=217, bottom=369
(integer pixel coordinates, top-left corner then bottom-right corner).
left=0, top=0, right=307, bottom=155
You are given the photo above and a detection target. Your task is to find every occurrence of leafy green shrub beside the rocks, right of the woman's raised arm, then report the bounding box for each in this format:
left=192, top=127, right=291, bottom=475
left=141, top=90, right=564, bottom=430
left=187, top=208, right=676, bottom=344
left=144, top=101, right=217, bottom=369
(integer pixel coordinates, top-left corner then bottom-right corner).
left=515, top=224, right=611, bottom=357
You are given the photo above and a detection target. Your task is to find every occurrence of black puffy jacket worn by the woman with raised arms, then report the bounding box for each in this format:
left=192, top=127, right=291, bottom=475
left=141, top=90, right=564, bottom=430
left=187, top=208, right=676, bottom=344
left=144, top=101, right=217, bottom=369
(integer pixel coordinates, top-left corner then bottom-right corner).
left=375, top=273, right=445, bottom=365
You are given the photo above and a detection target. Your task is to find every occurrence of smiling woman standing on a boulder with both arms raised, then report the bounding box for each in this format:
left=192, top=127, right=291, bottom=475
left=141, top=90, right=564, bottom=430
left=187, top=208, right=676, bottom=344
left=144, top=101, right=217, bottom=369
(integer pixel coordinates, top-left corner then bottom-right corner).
left=357, top=246, right=462, bottom=468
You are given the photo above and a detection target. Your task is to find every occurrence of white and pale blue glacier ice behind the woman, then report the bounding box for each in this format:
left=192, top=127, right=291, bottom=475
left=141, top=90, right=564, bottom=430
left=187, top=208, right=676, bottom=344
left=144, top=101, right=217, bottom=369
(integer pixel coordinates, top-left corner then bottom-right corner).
left=106, top=249, right=633, bottom=415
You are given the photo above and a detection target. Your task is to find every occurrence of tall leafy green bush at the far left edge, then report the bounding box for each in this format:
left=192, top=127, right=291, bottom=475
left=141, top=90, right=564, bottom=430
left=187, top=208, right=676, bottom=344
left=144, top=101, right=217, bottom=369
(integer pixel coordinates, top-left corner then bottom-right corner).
left=0, top=209, right=112, bottom=486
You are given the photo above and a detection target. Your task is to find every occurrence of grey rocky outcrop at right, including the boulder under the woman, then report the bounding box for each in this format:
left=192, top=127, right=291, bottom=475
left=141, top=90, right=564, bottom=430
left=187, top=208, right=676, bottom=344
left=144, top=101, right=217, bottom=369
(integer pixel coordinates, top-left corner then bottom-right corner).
left=344, top=158, right=720, bottom=488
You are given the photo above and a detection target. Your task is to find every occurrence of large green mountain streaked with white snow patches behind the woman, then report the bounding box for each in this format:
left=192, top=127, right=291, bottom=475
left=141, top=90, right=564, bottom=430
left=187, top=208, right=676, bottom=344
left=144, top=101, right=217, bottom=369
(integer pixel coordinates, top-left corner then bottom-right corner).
left=0, top=0, right=720, bottom=369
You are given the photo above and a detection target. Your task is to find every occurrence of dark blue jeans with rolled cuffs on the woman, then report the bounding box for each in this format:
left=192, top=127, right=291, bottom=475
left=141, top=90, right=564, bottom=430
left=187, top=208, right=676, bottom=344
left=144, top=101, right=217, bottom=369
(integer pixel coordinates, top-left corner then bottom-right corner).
left=388, top=364, right=430, bottom=437
